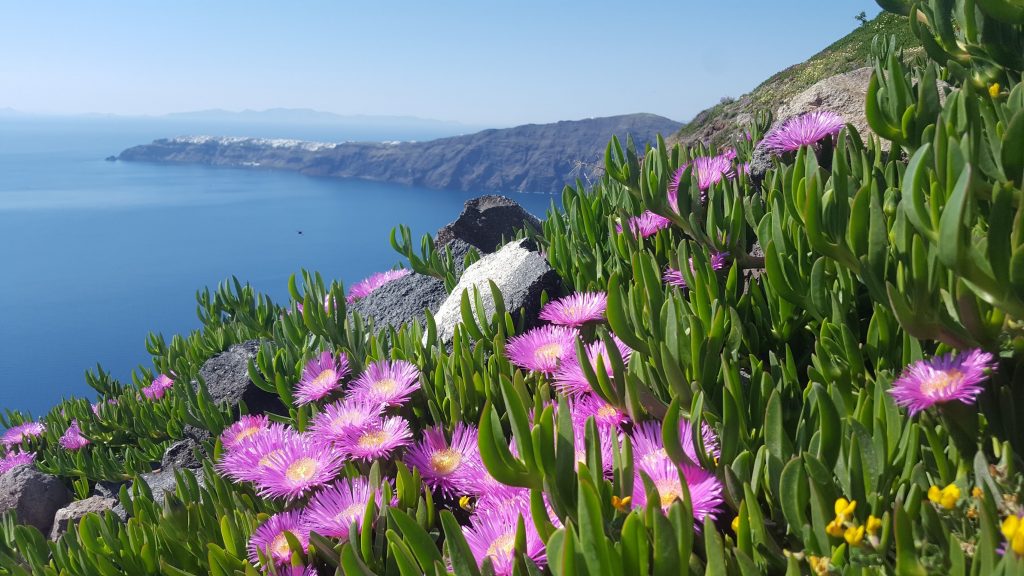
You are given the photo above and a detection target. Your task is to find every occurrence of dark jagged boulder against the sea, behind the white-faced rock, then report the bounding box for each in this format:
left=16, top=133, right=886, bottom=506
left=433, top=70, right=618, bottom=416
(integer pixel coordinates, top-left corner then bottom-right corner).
left=434, top=196, right=541, bottom=253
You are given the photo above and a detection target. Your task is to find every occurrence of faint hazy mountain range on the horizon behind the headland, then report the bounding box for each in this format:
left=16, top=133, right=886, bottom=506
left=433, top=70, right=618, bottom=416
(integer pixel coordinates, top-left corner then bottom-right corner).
left=161, top=108, right=479, bottom=131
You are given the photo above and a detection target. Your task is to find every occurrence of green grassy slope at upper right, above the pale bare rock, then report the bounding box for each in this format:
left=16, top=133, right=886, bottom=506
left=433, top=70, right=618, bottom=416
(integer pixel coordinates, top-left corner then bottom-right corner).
left=667, top=12, right=920, bottom=146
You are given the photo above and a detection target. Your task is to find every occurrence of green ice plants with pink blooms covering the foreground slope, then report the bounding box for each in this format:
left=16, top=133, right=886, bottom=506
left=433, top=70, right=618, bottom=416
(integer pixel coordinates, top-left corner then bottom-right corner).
left=0, top=0, right=1024, bottom=576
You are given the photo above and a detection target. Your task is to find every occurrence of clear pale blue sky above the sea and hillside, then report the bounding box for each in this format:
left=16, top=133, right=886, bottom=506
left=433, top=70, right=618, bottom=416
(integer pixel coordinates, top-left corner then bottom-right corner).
left=0, top=0, right=879, bottom=127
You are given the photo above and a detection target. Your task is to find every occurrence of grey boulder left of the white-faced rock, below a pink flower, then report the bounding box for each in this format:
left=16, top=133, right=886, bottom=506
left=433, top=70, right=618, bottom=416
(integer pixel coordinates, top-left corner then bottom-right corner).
left=350, top=274, right=447, bottom=330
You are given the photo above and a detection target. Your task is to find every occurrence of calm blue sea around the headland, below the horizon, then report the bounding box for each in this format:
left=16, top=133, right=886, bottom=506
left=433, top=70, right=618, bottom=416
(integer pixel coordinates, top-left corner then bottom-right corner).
left=0, top=119, right=554, bottom=415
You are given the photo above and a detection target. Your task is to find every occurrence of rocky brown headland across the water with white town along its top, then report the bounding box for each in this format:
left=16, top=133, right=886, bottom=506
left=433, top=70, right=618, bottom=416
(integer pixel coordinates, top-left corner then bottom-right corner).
left=118, top=114, right=682, bottom=193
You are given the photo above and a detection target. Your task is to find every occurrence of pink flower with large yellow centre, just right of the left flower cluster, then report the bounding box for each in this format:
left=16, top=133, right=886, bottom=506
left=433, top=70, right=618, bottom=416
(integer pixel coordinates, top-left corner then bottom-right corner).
left=406, top=424, right=480, bottom=495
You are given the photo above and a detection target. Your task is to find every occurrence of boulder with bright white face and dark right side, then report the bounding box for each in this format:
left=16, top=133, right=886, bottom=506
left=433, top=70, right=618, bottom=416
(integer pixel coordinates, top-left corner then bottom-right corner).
left=434, top=240, right=561, bottom=343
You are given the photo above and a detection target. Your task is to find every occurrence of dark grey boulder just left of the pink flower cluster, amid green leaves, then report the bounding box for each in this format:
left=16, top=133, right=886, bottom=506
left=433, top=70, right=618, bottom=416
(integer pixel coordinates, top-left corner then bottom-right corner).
left=199, top=340, right=283, bottom=414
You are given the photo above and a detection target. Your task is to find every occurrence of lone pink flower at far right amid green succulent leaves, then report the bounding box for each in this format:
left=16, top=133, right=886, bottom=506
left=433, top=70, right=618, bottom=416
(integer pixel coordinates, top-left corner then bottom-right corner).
left=889, top=349, right=995, bottom=416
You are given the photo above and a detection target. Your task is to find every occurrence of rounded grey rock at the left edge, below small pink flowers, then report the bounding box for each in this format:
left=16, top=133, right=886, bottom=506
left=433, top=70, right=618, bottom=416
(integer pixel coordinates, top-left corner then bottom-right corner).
left=0, top=464, right=72, bottom=534
